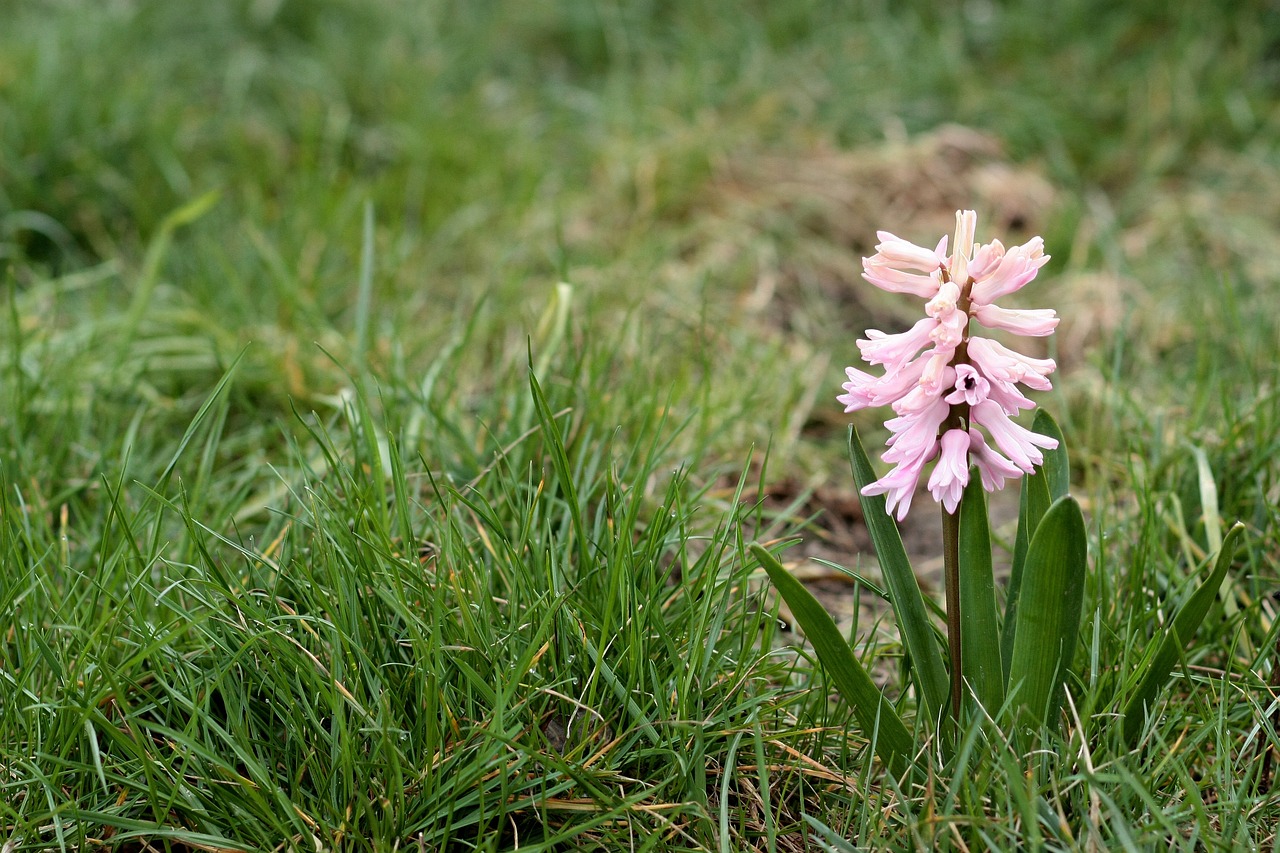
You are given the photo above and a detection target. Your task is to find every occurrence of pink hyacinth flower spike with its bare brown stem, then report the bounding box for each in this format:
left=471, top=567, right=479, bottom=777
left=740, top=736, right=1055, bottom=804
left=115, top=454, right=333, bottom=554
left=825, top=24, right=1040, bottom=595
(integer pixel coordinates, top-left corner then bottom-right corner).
left=838, top=210, right=1057, bottom=716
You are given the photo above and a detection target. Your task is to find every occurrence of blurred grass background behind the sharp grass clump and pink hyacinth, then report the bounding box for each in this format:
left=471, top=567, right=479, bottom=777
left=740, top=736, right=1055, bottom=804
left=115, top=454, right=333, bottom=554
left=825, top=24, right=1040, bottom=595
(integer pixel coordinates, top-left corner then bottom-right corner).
left=0, top=0, right=1280, bottom=844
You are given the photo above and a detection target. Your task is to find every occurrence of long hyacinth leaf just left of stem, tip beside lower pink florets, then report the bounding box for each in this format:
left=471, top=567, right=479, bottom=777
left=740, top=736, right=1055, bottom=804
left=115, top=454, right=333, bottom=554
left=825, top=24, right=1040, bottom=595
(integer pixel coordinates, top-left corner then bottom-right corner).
left=849, top=427, right=951, bottom=721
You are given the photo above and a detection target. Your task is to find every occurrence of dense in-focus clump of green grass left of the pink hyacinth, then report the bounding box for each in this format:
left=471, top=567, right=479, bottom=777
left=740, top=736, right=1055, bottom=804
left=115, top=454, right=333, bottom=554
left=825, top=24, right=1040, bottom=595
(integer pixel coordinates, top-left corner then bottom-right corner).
left=4, top=298, right=829, bottom=849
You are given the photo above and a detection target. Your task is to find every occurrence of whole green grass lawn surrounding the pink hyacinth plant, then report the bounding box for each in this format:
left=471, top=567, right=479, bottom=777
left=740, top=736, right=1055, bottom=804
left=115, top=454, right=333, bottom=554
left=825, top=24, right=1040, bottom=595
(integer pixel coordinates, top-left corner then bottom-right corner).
left=0, top=0, right=1280, bottom=853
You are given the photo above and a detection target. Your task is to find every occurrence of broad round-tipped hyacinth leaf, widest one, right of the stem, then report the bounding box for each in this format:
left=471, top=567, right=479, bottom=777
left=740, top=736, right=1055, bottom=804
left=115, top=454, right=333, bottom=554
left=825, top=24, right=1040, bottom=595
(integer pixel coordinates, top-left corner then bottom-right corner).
left=1009, top=496, right=1088, bottom=731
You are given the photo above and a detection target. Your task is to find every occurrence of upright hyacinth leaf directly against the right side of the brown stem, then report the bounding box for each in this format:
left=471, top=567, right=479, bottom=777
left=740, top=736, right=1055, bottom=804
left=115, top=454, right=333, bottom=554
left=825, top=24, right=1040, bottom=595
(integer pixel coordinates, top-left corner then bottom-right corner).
left=960, top=470, right=1005, bottom=715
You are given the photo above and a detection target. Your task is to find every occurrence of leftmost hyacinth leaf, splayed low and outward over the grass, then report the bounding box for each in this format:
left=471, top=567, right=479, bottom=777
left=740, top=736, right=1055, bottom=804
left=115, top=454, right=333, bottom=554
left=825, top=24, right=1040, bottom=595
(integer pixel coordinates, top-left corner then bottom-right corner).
left=751, top=544, right=915, bottom=775
